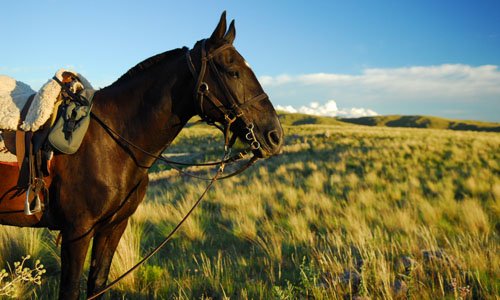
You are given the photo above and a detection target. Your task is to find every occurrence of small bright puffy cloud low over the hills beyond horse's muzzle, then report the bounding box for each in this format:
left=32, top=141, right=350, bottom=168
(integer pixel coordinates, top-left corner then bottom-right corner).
left=276, top=100, right=378, bottom=117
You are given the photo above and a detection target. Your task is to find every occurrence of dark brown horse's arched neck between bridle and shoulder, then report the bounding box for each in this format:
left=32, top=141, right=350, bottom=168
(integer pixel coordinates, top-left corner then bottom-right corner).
left=94, top=59, right=195, bottom=159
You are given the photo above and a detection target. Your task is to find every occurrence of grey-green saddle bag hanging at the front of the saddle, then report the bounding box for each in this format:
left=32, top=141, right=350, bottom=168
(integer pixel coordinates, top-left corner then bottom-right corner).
left=48, top=89, right=95, bottom=154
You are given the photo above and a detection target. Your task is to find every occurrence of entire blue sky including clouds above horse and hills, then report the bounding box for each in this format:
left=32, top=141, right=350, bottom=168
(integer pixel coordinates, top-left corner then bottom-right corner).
left=0, top=0, right=500, bottom=122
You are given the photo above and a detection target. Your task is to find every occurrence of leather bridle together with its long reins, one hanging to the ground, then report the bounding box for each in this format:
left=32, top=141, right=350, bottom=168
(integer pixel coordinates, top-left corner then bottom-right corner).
left=85, top=40, right=267, bottom=300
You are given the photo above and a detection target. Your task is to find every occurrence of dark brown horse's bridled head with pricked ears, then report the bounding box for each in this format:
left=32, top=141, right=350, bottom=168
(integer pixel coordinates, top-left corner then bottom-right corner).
left=188, top=12, right=283, bottom=157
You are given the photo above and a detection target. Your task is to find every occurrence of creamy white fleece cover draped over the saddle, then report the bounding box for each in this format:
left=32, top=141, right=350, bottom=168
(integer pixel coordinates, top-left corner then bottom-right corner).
left=0, top=69, right=93, bottom=131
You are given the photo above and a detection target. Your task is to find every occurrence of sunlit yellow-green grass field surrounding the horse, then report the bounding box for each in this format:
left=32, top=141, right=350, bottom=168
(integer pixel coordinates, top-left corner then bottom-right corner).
left=0, top=120, right=500, bottom=299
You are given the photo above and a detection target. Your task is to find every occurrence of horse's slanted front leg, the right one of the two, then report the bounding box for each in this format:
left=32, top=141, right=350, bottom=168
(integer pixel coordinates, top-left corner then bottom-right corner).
left=87, top=218, right=128, bottom=297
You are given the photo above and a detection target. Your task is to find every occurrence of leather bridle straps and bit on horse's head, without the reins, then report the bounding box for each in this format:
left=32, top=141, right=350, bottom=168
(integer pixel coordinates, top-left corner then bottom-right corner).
left=186, top=40, right=268, bottom=150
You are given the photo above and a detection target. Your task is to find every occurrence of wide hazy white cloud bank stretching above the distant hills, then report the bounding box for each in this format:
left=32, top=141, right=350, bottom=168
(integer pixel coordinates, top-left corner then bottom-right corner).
left=259, top=64, right=500, bottom=122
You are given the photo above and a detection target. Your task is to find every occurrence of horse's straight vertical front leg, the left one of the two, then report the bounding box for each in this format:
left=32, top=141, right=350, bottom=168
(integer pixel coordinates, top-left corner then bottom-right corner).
left=59, top=231, right=92, bottom=300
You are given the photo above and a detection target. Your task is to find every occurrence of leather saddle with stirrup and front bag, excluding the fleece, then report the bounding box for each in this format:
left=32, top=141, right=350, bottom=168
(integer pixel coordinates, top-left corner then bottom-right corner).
left=1, top=72, right=94, bottom=215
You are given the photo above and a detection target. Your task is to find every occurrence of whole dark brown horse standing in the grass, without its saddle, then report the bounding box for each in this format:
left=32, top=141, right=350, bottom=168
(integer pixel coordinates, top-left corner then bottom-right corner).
left=0, top=13, right=283, bottom=299
